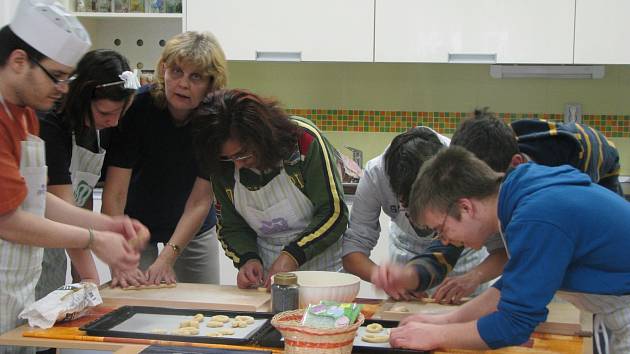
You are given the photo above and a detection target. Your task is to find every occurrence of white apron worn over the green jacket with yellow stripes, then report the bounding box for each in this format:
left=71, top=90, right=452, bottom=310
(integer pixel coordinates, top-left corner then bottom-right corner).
left=234, top=168, right=342, bottom=272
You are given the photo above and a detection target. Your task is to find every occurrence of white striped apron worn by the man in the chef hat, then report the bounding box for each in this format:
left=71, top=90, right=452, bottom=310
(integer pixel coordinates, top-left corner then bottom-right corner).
left=0, top=96, right=47, bottom=353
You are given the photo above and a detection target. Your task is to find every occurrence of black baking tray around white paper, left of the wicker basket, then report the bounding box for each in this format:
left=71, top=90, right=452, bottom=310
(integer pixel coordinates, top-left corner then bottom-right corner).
left=80, top=306, right=274, bottom=345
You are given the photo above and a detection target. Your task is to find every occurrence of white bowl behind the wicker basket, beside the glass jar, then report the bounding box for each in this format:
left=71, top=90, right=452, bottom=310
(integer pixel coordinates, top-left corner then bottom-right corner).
left=292, top=271, right=361, bottom=308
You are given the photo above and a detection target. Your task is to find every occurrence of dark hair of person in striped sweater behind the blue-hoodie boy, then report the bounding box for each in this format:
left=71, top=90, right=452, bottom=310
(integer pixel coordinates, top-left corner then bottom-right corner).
left=451, top=107, right=519, bottom=172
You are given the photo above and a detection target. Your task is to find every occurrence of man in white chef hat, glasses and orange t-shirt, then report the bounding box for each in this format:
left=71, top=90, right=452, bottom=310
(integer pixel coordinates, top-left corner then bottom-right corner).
left=0, top=0, right=148, bottom=353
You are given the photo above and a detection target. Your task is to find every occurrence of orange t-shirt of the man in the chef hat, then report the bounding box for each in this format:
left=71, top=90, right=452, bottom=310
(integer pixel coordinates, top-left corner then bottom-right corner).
left=0, top=100, right=39, bottom=215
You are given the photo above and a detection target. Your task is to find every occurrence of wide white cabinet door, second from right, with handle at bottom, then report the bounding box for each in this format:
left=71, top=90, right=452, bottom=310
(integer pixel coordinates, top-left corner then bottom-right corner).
left=374, top=0, right=576, bottom=64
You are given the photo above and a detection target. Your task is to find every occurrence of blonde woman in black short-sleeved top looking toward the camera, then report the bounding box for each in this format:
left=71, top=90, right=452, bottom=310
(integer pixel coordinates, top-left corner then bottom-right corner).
left=103, top=32, right=227, bottom=288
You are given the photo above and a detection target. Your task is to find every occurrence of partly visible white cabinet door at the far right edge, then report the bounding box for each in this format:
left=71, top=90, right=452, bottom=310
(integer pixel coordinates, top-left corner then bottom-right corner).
left=575, top=0, right=630, bottom=64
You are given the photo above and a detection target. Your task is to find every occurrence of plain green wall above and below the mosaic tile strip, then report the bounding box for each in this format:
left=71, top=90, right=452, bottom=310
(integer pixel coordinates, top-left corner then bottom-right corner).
left=229, top=62, right=630, bottom=175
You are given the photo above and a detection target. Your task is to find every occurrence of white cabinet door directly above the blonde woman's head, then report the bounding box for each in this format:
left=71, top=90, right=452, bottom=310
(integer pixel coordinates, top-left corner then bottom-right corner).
left=186, top=0, right=374, bottom=62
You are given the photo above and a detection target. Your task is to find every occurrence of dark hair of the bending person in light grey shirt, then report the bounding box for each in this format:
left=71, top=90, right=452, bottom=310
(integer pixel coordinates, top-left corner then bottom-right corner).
left=383, top=127, right=444, bottom=207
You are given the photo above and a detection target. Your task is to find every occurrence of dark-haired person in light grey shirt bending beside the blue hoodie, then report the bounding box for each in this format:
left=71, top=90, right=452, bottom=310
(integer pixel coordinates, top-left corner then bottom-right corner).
left=343, top=127, right=504, bottom=303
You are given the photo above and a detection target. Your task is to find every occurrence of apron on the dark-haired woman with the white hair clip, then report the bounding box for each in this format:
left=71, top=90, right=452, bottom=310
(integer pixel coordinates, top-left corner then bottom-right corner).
left=35, top=134, right=106, bottom=299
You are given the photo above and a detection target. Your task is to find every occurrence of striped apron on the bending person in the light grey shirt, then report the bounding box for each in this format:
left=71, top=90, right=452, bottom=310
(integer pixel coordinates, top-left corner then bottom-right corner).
left=389, top=218, right=490, bottom=296
